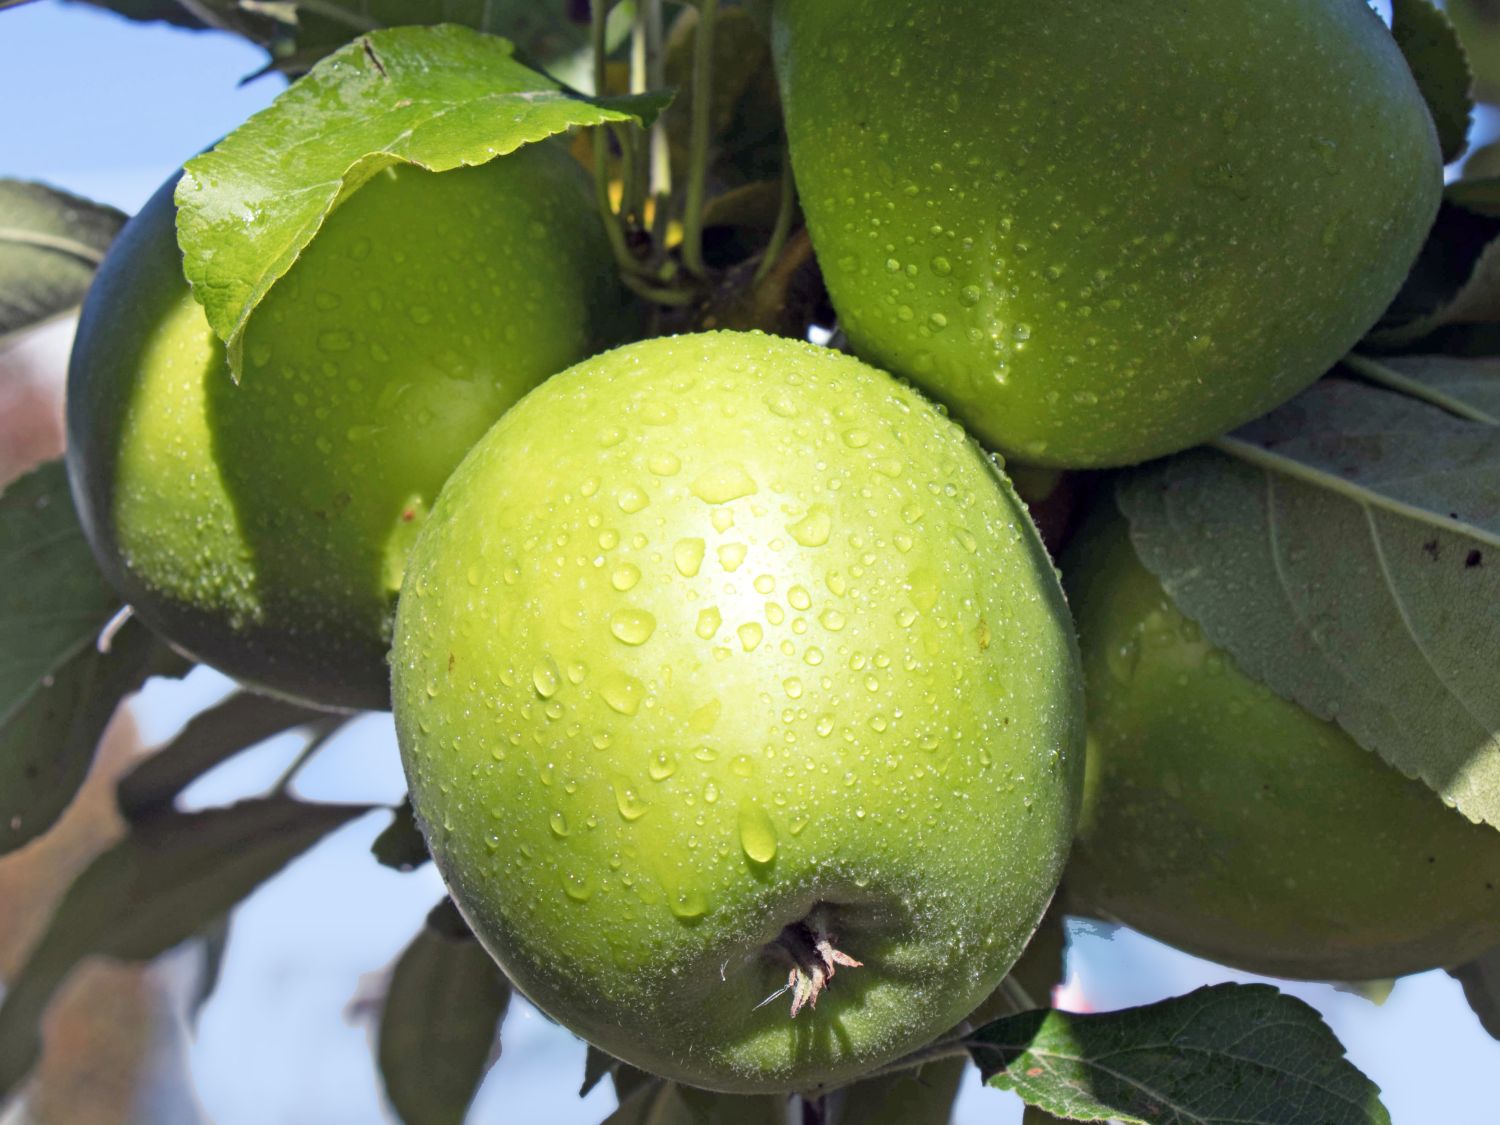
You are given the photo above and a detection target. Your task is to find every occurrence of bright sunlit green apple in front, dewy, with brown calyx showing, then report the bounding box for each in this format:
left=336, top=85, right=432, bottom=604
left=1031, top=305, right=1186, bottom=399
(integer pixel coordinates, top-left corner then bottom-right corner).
left=392, top=333, right=1083, bottom=1094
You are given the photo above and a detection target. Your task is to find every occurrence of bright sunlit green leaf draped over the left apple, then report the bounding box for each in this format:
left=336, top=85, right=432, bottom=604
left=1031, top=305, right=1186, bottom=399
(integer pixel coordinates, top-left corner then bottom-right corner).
left=177, top=26, right=666, bottom=378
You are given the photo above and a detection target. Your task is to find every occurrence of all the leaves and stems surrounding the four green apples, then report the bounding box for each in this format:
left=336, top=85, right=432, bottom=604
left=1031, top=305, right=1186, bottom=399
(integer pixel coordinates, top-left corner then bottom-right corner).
left=0, top=0, right=1500, bottom=1125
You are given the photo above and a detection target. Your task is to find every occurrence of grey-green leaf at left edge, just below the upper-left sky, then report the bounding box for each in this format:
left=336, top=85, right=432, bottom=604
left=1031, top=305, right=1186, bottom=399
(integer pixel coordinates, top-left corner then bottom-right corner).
left=0, top=180, right=125, bottom=348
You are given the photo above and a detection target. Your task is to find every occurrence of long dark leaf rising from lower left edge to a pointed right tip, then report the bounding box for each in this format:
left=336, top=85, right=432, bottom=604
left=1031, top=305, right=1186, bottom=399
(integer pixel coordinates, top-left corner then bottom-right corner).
left=0, top=797, right=371, bottom=1101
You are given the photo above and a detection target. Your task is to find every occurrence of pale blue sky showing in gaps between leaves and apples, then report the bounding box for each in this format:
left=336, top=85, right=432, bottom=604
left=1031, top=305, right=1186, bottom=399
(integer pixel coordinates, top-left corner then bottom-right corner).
left=0, top=0, right=1500, bottom=1125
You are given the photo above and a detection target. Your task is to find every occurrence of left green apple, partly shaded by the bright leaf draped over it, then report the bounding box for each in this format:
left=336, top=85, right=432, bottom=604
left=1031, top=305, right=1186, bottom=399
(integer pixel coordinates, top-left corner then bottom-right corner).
left=68, top=144, right=626, bottom=708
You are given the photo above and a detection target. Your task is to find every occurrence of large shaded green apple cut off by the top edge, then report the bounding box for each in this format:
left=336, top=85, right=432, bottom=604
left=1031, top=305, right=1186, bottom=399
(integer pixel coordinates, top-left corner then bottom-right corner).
left=774, top=0, right=1443, bottom=467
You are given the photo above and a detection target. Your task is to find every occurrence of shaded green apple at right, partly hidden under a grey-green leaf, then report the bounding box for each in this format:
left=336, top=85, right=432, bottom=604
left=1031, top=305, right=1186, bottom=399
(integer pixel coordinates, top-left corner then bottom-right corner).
left=1064, top=498, right=1500, bottom=981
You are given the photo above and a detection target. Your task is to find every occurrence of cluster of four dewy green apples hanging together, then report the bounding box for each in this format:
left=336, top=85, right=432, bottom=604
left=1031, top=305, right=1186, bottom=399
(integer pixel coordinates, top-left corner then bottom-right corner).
left=58, top=0, right=1500, bottom=1092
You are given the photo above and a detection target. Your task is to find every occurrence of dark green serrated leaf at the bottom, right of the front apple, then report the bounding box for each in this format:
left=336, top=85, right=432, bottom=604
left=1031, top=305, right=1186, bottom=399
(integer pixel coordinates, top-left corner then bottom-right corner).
left=968, top=984, right=1391, bottom=1125
